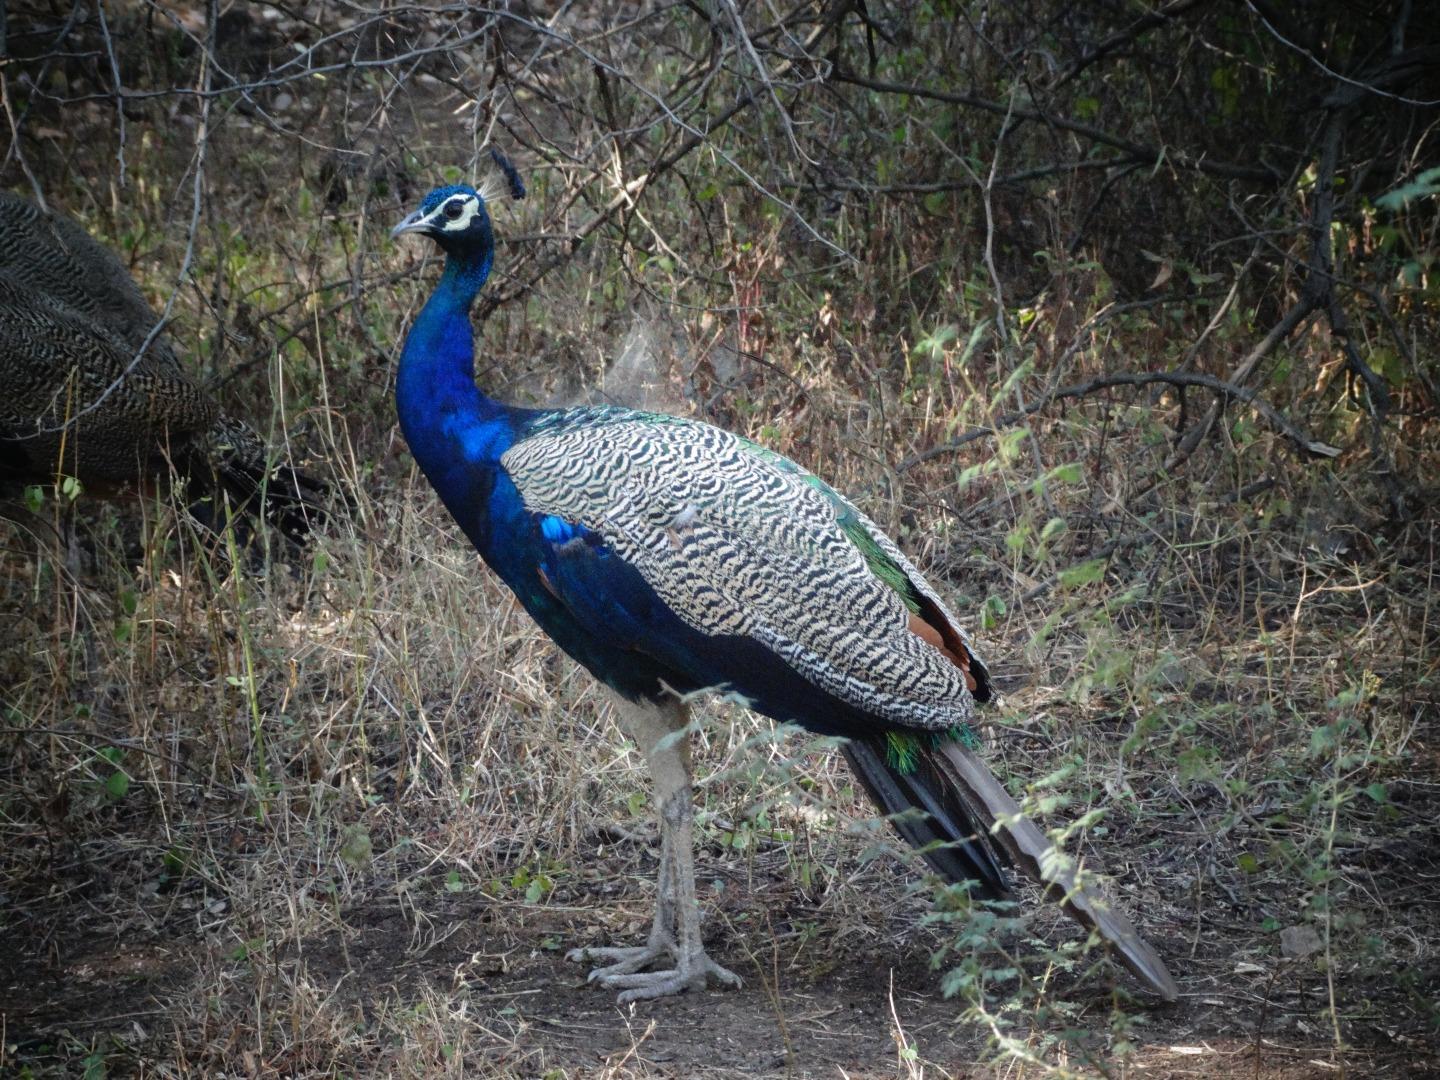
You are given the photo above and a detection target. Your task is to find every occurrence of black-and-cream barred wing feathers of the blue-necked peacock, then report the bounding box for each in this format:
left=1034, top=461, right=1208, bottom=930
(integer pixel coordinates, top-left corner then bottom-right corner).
left=501, top=409, right=978, bottom=730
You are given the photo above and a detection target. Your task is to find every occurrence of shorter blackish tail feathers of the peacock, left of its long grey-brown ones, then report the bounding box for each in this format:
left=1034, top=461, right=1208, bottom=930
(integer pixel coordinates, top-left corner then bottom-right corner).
left=844, top=739, right=1009, bottom=900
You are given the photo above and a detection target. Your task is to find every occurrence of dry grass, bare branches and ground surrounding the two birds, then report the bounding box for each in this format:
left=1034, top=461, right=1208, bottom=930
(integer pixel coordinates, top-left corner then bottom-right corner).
left=0, top=0, right=1440, bottom=1077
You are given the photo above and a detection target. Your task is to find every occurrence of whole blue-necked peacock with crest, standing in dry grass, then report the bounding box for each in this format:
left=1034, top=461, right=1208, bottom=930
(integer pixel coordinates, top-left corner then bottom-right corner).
left=393, top=153, right=1176, bottom=1002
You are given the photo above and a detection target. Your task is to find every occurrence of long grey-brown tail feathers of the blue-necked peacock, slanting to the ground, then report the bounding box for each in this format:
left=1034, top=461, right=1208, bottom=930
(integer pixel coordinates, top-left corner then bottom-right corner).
left=924, top=742, right=1179, bottom=1001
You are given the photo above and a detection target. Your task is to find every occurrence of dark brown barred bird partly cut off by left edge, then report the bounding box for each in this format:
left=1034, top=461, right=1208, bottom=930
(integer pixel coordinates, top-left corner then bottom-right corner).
left=0, top=193, right=328, bottom=540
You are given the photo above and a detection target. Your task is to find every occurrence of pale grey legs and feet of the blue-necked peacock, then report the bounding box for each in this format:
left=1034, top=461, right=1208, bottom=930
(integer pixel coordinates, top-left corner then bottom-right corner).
left=570, top=698, right=740, bottom=1004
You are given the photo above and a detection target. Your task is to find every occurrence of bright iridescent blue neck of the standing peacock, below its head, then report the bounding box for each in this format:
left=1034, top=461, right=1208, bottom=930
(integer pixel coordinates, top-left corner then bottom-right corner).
left=395, top=238, right=513, bottom=469
